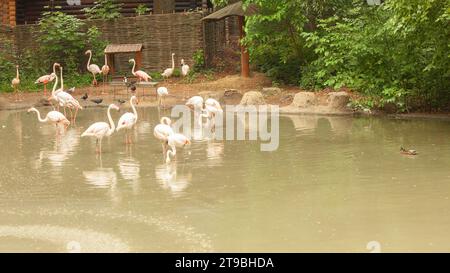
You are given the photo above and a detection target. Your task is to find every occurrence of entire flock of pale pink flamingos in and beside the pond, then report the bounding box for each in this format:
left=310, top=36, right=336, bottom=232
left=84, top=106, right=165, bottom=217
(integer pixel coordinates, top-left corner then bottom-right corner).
left=20, top=50, right=223, bottom=163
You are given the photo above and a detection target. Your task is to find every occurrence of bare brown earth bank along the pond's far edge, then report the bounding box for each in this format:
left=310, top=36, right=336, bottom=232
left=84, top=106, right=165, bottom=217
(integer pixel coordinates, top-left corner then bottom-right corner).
left=0, top=73, right=450, bottom=120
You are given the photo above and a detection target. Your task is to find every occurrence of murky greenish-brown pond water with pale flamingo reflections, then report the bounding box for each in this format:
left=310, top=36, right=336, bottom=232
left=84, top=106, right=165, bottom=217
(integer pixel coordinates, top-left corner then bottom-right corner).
left=0, top=108, right=450, bottom=252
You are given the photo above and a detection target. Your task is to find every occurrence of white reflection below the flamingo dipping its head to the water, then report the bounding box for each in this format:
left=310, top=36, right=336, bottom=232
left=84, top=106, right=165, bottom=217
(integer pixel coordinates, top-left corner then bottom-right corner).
left=155, top=162, right=192, bottom=197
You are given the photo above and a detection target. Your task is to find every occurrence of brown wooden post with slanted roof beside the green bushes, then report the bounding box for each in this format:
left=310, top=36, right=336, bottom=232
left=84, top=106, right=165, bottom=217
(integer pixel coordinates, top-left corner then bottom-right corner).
left=202, top=1, right=258, bottom=78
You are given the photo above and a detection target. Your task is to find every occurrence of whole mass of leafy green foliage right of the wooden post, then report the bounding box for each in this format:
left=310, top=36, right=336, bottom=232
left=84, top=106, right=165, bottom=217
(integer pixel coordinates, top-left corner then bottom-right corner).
left=244, top=0, right=450, bottom=111
